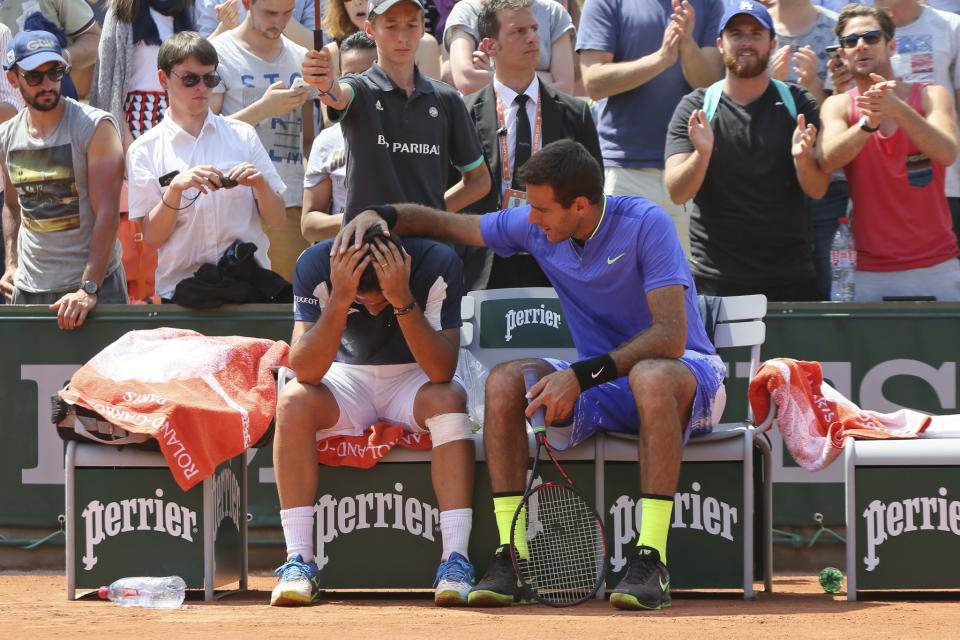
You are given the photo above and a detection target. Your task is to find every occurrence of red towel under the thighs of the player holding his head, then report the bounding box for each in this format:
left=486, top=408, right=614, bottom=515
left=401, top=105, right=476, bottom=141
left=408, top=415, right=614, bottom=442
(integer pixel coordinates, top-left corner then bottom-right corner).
left=317, top=422, right=433, bottom=469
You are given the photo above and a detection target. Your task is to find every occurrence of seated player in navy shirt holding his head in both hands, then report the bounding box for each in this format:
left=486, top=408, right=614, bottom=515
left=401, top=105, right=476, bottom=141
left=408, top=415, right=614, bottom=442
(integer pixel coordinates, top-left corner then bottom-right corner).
left=270, top=228, right=476, bottom=606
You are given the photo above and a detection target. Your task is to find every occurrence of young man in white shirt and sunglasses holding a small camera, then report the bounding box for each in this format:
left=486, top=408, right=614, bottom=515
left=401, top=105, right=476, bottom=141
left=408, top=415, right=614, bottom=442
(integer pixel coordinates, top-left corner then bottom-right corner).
left=127, top=31, right=285, bottom=300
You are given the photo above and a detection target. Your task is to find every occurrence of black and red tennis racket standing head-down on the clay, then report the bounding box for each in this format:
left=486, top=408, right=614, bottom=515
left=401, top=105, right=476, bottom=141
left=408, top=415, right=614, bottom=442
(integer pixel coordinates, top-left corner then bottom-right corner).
left=510, top=363, right=607, bottom=607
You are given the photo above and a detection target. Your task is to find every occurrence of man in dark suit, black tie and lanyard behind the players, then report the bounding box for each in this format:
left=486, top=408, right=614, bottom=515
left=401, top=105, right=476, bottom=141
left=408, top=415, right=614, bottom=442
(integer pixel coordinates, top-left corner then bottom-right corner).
left=461, top=0, right=602, bottom=290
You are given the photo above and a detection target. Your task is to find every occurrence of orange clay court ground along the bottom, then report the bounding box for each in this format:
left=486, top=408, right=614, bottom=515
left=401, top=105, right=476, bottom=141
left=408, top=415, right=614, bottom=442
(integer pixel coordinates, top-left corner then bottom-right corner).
left=0, top=574, right=960, bottom=640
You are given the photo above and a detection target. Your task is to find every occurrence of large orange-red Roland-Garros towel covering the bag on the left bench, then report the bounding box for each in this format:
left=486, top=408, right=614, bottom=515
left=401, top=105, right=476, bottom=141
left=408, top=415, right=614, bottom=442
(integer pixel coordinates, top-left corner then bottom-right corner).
left=60, top=328, right=290, bottom=491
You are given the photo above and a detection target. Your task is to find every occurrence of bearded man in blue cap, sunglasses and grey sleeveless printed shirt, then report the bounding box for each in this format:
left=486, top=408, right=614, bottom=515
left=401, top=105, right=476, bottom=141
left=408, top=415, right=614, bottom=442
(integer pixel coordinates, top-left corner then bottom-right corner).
left=0, top=31, right=127, bottom=329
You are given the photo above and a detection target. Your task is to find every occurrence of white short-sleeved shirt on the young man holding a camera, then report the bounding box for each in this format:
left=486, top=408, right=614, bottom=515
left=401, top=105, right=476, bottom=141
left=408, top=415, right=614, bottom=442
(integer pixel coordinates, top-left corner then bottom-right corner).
left=127, top=111, right=286, bottom=298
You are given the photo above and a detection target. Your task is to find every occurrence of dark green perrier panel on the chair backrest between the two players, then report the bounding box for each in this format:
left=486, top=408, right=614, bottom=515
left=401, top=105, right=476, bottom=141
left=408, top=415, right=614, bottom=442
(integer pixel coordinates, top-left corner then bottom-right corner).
left=480, top=298, right=574, bottom=349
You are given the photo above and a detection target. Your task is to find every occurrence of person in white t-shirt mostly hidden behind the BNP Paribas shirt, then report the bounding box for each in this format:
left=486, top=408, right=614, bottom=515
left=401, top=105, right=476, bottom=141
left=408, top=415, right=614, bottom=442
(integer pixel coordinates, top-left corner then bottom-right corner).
left=300, top=31, right=377, bottom=242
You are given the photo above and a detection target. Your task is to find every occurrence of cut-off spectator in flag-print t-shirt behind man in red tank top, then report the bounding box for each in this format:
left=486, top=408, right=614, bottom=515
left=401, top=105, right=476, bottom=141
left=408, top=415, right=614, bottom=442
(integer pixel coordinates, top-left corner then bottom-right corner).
left=876, top=0, right=960, bottom=252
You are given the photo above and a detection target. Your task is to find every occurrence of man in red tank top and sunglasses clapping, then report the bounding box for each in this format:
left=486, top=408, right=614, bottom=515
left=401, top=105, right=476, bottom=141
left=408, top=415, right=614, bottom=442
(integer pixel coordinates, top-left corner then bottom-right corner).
left=820, top=5, right=960, bottom=302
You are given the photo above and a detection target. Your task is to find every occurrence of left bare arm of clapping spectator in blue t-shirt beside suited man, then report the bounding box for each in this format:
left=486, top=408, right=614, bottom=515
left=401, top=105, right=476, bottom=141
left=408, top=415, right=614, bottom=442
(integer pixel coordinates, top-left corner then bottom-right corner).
left=580, top=22, right=680, bottom=100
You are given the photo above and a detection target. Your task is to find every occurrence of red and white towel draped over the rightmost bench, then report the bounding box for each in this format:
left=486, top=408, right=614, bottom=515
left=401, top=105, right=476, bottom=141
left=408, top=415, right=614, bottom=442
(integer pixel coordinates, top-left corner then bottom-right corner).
left=748, top=358, right=931, bottom=471
